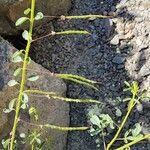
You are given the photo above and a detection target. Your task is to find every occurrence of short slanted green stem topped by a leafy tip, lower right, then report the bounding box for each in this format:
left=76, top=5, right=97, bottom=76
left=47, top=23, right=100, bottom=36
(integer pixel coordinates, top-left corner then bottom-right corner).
left=106, top=94, right=135, bottom=150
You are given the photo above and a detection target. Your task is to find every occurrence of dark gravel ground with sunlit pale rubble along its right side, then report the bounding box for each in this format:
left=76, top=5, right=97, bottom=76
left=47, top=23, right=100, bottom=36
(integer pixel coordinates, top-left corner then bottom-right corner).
left=31, top=0, right=150, bottom=150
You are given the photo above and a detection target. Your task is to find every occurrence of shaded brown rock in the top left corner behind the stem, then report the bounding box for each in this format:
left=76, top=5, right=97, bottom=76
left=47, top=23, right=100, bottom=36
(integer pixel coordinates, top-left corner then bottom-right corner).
left=0, top=0, right=71, bottom=34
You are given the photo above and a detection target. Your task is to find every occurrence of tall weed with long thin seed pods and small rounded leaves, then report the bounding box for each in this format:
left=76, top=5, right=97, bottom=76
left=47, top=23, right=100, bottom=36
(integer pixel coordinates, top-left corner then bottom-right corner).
left=2, top=0, right=108, bottom=150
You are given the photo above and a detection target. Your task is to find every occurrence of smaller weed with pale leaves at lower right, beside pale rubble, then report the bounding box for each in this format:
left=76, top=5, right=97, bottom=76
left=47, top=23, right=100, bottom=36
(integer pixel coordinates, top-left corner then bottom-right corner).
left=90, top=81, right=150, bottom=150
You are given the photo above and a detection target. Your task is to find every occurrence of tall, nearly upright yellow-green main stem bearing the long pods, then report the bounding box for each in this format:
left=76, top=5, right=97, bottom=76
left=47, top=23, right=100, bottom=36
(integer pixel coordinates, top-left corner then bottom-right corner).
left=10, top=0, right=36, bottom=150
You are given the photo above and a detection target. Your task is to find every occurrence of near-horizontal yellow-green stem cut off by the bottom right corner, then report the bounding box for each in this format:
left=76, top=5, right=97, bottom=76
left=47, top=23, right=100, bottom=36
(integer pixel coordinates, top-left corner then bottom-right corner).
left=116, top=134, right=150, bottom=150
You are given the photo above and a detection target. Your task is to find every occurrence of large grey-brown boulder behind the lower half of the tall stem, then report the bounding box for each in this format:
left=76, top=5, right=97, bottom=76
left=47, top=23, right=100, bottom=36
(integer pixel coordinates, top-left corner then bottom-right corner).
left=0, top=38, right=69, bottom=150
